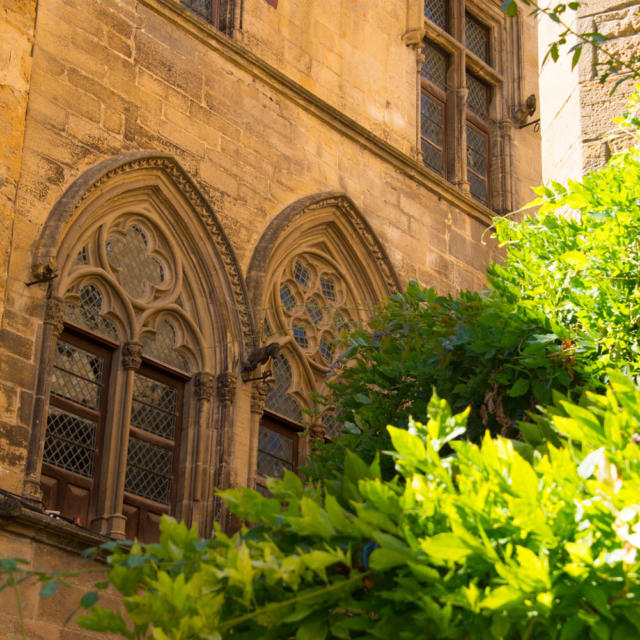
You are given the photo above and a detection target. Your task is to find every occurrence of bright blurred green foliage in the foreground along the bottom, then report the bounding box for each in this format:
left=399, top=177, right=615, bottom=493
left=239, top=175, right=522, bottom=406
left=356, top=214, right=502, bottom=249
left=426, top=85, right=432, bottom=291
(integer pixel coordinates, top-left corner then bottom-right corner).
left=37, top=382, right=640, bottom=640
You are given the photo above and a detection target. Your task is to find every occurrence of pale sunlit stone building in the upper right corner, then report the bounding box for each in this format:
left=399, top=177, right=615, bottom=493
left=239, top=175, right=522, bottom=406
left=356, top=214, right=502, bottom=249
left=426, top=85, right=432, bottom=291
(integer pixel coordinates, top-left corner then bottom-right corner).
left=539, top=0, right=640, bottom=182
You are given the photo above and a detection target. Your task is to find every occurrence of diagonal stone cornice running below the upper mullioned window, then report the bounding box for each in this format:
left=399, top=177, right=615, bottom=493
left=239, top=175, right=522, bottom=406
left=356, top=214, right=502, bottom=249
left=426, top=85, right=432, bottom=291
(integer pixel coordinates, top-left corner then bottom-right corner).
left=139, top=0, right=496, bottom=226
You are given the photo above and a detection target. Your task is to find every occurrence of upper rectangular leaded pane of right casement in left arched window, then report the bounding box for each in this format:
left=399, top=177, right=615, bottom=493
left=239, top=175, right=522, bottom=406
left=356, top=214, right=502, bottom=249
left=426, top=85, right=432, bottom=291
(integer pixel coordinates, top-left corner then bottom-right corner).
left=131, top=373, right=178, bottom=440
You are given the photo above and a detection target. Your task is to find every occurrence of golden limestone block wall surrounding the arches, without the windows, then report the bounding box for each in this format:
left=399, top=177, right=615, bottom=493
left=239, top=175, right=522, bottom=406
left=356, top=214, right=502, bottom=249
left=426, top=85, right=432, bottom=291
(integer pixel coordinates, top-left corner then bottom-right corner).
left=0, top=0, right=539, bottom=640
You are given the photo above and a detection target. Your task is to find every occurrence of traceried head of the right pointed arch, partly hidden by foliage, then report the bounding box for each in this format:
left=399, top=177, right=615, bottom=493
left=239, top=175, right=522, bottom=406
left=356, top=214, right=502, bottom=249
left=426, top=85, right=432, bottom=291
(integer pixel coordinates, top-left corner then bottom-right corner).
left=247, top=193, right=398, bottom=436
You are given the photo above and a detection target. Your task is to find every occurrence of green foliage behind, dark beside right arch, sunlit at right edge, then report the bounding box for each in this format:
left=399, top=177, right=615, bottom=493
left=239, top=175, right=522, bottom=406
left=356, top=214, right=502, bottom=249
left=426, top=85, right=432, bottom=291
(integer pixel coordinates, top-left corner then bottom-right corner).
left=316, top=141, right=640, bottom=478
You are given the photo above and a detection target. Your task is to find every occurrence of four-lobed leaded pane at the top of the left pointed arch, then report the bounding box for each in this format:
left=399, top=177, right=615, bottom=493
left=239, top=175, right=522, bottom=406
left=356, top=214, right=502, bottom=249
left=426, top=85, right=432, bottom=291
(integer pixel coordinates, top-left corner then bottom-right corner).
left=106, top=225, right=164, bottom=298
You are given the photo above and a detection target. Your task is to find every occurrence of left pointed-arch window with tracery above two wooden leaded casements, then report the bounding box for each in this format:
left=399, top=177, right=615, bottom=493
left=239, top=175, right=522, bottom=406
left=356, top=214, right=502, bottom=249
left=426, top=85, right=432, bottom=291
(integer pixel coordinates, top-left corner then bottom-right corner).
left=41, top=218, right=202, bottom=540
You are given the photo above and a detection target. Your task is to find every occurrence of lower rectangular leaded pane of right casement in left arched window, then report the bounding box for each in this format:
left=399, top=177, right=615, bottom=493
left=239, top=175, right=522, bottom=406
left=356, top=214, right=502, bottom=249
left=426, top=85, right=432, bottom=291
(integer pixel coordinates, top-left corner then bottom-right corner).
left=124, top=436, right=173, bottom=504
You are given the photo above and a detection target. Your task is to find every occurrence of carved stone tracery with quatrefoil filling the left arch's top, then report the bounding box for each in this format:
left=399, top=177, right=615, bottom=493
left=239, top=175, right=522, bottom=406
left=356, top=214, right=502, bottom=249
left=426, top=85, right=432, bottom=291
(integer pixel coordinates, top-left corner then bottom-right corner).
left=63, top=214, right=201, bottom=372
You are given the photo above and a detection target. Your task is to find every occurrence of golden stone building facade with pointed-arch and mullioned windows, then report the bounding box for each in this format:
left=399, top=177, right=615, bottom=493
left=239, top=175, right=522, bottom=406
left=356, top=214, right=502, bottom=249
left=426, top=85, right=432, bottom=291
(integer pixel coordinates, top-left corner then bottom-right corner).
left=0, top=0, right=540, bottom=640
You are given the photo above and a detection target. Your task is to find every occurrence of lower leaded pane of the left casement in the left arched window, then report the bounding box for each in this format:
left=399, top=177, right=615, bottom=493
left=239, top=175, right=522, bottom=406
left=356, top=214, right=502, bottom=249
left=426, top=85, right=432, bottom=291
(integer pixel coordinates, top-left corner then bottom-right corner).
left=42, top=407, right=98, bottom=478
